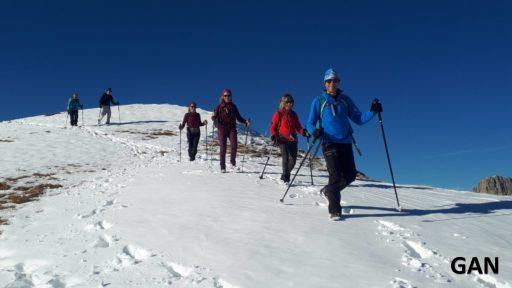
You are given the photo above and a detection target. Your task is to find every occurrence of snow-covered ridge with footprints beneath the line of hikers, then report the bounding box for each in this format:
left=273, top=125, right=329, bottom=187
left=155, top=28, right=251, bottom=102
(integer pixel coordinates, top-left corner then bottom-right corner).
left=0, top=105, right=512, bottom=287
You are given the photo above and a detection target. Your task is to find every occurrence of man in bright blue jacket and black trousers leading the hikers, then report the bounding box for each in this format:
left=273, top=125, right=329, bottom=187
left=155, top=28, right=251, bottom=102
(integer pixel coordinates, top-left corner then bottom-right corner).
left=307, top=69, right=382, bottom=220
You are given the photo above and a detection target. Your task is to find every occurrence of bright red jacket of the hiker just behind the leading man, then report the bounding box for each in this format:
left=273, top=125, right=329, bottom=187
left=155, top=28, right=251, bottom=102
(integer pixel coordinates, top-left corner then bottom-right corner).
left=270, top=109, right=304, bottom=142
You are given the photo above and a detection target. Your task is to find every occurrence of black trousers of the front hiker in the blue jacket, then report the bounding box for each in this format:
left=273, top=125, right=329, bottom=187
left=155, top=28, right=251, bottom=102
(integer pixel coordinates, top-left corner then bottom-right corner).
left=323, top=143, right=357, bottom=213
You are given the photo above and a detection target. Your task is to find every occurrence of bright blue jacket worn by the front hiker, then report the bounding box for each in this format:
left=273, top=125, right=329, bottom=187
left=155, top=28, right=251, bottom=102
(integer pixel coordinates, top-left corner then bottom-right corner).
left=307, top=90, right=375, bottom=143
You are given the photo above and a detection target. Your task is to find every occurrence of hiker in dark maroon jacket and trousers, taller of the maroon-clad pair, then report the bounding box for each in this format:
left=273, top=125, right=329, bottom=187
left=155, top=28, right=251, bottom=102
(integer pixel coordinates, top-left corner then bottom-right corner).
left=212, top=89, right=251, bottom=173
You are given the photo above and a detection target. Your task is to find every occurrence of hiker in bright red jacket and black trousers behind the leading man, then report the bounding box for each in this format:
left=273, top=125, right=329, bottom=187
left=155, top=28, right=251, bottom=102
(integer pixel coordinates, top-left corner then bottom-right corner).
left=270, top=94, right=310, bottom=183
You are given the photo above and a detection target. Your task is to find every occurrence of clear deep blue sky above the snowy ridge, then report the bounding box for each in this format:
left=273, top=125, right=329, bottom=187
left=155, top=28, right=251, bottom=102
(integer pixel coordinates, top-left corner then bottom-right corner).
left=0, top=1, right=512, bottom=189
